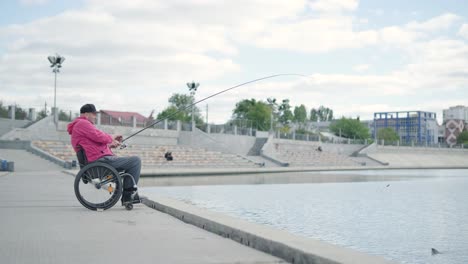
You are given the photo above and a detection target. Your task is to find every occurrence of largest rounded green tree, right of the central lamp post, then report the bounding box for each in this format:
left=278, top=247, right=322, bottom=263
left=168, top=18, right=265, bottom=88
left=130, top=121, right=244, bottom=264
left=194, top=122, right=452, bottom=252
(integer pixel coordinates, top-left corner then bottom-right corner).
left=232, top=98, right=272, bottom=130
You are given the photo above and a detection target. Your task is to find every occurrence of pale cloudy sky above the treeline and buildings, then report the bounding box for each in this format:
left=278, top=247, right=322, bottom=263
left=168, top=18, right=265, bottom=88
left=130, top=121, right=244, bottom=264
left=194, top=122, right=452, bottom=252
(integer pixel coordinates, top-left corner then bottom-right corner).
left=0, top=0, right=468, bottom=124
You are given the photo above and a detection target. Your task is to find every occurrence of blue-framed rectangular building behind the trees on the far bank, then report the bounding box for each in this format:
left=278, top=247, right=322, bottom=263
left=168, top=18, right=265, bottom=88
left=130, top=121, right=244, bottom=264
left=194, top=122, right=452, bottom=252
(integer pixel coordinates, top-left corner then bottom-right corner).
left=373, top=111, right=439, bottom=145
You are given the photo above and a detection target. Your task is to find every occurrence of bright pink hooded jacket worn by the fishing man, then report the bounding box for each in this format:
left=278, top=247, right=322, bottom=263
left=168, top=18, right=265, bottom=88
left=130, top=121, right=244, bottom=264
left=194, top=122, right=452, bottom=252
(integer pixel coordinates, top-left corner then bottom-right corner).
left=67, top=117, right=114, bottom=162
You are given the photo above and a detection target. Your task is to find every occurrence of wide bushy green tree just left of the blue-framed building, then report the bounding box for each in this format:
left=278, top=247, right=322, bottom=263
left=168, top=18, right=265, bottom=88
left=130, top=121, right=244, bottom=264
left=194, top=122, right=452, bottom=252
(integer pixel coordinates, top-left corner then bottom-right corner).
left=330, top=117, right=369, bottom=139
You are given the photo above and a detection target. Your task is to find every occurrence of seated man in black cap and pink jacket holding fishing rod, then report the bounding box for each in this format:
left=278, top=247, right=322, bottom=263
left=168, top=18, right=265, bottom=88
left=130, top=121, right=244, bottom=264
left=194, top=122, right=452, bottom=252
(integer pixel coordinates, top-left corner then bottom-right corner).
left=67, top=104, right=141, bottom=205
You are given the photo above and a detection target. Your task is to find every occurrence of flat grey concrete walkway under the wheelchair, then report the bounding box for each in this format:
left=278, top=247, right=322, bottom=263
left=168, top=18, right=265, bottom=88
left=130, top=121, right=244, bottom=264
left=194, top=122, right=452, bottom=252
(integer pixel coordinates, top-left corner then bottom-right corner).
left=0, top=149, right=284, bottom=264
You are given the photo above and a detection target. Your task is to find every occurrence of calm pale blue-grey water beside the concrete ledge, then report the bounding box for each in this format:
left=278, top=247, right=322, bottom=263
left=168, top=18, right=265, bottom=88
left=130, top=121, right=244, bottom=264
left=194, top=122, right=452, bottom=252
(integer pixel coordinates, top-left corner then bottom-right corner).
left=143, top=170, right=468, bottom=263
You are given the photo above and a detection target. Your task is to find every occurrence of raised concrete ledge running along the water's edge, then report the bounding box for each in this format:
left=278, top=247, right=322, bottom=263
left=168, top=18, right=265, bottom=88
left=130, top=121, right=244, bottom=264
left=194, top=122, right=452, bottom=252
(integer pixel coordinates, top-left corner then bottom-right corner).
left=144, top=197, right=393, bottom=264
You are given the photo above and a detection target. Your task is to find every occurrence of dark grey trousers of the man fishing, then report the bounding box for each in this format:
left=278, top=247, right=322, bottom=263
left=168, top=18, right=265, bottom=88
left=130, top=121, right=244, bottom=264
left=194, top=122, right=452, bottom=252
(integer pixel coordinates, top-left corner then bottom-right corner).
left=99, top=156, right=141, bottom=189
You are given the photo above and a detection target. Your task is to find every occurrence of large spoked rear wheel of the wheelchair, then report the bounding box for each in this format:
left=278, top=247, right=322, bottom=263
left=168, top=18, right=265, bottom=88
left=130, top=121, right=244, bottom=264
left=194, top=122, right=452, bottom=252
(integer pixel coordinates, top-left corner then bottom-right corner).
left=75, top=162, right=123, bottom=211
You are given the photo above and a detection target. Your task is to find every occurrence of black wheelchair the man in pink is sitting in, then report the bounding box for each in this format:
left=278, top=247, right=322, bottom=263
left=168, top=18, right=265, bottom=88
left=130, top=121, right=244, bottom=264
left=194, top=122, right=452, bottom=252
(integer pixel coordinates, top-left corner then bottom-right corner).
left=74, top=148, right=141, bottom=211
